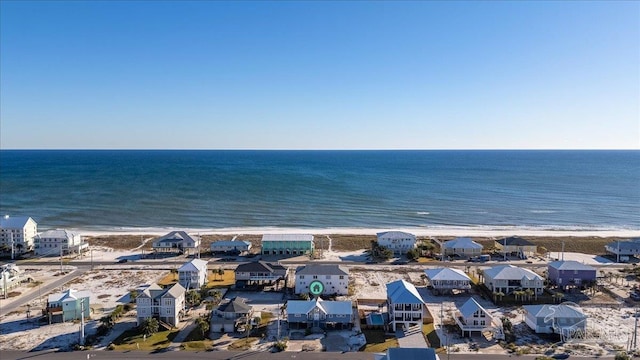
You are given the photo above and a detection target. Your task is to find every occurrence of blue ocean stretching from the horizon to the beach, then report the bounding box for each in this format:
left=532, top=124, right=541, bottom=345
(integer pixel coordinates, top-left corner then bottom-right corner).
left=0, top=150, right=640, bottom=230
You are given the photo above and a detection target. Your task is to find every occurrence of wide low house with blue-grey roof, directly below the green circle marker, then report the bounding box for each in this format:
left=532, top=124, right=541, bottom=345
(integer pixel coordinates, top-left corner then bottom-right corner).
left=286, top=297, right=354, bottom=329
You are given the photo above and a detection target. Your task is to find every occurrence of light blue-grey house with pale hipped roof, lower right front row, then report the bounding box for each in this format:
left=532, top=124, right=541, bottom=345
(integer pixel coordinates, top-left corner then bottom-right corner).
left=523, top=303, right=587, bottom=338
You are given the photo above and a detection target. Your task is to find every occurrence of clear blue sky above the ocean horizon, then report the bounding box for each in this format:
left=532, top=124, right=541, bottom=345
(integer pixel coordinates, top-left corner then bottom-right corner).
left=0, top=1, right=640, bottom=149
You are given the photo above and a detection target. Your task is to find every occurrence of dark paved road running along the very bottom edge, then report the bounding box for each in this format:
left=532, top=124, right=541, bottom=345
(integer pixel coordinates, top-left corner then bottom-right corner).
left=1, top=351, right=614, bottom=360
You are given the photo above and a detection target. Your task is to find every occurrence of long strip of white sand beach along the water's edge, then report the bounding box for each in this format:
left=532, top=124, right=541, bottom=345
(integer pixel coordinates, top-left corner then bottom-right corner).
left=68, top=226, right=640, bottom=238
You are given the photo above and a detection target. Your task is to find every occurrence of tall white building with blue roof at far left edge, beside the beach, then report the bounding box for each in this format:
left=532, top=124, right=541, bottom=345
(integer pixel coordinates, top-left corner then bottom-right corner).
left=0, top=215, right=38, bottom=254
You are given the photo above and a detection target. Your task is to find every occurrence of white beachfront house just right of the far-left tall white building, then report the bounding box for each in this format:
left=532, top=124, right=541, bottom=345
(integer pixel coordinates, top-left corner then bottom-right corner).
left=34, top=230, right=89, bottom=256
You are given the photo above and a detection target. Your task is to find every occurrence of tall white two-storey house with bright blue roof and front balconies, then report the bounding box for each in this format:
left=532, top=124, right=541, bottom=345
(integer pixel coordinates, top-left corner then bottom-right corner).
left=387, top=280, right=426, bottom=331
